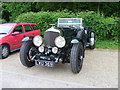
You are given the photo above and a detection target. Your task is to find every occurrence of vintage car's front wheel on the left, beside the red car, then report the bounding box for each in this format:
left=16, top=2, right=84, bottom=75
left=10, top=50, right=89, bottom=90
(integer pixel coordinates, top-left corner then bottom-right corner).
left=20, top=41, right=36, bottom=67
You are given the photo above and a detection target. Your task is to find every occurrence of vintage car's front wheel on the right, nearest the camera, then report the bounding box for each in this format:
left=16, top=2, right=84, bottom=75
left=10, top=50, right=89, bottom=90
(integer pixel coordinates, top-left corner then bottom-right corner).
left=70, top=42, right=84, bottom=73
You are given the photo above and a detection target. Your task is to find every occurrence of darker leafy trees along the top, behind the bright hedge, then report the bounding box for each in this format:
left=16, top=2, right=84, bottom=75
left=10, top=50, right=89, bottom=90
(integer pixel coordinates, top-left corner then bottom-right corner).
left=2, top=2, right=120, bottom=21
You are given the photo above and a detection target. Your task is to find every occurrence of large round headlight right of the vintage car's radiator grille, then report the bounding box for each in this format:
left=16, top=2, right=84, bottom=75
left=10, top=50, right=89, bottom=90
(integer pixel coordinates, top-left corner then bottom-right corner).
left=55, top=36, right=66, bottom=48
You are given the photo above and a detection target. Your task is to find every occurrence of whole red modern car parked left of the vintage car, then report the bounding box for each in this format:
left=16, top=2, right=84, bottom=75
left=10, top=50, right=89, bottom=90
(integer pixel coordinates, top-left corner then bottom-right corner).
left=0, top=23, right=41, bottom=59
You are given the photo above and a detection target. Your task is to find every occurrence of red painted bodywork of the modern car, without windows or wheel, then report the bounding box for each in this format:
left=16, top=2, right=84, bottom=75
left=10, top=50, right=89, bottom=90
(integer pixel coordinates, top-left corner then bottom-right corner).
left=0, top=23, right=41, bottom=51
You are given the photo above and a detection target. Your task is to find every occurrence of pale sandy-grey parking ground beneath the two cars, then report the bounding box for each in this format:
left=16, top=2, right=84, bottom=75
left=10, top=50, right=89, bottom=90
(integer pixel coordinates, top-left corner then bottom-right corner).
left=0, top=49, right=118, bottom=88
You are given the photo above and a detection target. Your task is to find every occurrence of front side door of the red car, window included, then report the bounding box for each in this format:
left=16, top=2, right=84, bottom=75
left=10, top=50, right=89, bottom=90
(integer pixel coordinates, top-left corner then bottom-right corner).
left=11, top=25, right=25, bottom=49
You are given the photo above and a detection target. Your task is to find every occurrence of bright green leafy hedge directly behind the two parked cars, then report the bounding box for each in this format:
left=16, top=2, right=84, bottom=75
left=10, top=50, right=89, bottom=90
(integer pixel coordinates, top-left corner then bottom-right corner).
left=15, top=10, right=119, bottom=40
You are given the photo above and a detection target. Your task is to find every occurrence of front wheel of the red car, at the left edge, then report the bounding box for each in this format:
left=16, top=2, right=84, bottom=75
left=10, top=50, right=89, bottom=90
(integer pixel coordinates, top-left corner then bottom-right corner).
left=0, top=44, right=10, bottom=59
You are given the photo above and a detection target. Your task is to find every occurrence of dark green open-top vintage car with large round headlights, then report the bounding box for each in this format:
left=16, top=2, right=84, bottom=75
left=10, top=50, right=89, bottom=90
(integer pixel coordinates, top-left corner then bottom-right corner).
left=20, top=18, right=95, bottom=73
